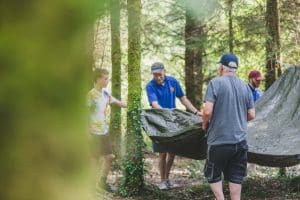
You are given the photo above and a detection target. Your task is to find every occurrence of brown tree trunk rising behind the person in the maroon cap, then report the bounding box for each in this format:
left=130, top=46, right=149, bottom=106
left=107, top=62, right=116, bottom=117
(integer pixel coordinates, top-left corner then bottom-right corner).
left=266, top=0, right=281, bottom=89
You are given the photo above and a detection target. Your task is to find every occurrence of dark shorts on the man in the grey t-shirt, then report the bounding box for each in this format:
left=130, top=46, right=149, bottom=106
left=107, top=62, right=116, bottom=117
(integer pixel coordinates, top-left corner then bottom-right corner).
left=204, top=140, right=248, bottom=184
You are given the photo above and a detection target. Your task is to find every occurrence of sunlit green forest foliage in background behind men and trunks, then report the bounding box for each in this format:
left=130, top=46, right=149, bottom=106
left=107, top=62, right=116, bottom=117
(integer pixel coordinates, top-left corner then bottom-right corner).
left=97, top=0, right=300, bottom=107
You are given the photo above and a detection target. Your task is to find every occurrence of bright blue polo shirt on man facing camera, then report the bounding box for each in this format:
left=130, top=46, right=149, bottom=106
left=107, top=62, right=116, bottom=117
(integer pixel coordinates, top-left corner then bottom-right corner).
left=146, top=76, right=184, bottom=108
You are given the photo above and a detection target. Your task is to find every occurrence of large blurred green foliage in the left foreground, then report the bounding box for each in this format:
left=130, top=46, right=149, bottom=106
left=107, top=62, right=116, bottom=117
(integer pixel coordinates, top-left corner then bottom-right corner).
left=0, top=0, right=101, bottom=200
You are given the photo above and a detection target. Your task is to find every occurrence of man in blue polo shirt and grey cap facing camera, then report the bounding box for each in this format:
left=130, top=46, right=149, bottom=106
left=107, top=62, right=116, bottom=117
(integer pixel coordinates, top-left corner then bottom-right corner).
left=146, top=62, right=201, bottom=190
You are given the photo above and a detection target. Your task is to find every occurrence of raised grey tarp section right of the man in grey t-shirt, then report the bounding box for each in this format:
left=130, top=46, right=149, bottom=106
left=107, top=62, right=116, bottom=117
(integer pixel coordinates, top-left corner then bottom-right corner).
left=248, top=67, right=300, bottom=167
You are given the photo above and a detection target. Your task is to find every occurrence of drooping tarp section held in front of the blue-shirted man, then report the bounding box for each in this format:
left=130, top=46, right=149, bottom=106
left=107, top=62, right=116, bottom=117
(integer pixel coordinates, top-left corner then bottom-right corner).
left=141, top=109, right=207, bottom=160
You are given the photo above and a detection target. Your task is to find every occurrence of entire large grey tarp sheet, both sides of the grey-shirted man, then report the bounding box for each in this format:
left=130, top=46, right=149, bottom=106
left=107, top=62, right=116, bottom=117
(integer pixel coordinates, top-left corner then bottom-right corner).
left=142, top=67, right=300, bottom=167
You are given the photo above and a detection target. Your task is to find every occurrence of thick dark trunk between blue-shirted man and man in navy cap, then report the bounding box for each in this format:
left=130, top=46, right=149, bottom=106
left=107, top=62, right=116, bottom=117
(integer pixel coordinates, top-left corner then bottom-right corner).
left=185, top=9, right=206, bottom=109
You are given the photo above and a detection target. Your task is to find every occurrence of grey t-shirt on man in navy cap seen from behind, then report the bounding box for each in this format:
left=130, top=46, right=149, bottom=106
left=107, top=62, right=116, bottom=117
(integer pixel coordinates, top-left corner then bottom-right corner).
left=204, top=75, right=254, bottom=145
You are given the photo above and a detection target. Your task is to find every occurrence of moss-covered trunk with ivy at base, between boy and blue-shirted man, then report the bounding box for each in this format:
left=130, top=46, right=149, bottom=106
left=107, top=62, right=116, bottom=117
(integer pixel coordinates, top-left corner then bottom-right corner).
left=121, top=0, right=144, bottom=196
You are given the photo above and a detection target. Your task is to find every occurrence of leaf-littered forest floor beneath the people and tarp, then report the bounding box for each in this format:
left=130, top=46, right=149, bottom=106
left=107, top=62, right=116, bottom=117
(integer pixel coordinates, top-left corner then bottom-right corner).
left=97, top=151, right=300, bottom=200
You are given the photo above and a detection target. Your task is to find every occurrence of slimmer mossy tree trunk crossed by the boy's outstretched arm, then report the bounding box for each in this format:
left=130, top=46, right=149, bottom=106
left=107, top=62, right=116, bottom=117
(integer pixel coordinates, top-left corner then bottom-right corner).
left=109, top=0, right=122, bottom=157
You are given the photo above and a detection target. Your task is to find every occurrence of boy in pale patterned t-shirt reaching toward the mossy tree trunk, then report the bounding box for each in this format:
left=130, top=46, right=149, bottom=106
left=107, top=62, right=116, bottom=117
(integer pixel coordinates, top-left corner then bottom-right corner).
left=88, top=69, right=127, bottom=190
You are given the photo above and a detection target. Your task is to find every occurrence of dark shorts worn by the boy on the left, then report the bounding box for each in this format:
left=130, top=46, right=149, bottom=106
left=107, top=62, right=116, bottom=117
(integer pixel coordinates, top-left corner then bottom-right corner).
left=90, top=134, right=112, bottom=158
